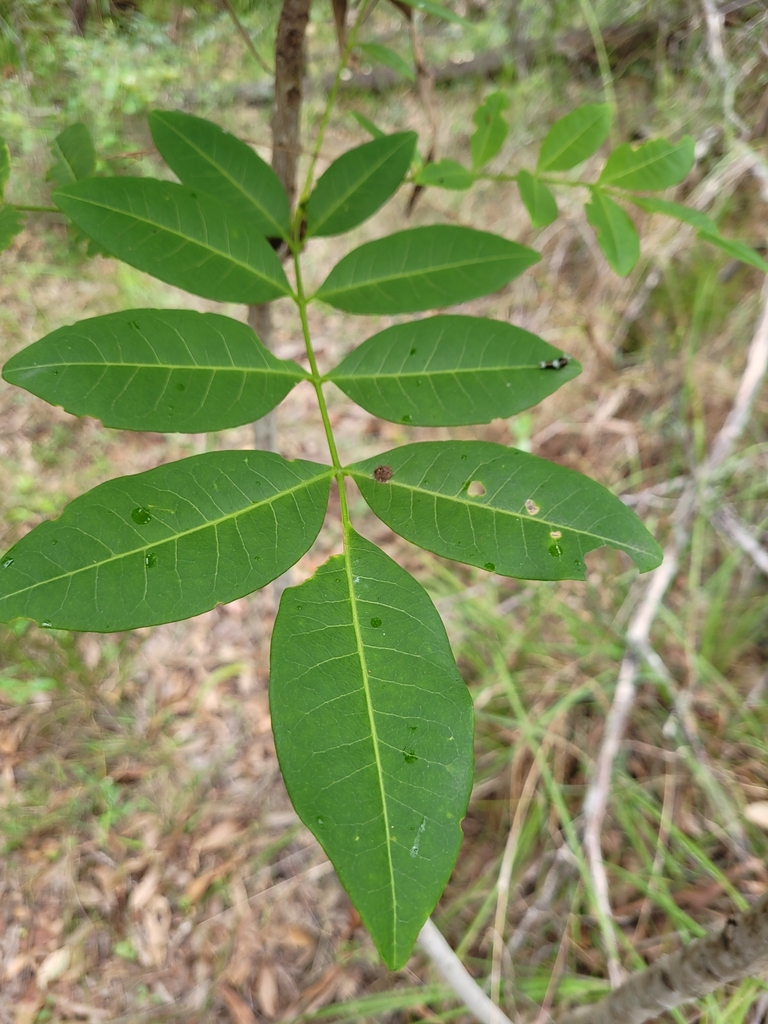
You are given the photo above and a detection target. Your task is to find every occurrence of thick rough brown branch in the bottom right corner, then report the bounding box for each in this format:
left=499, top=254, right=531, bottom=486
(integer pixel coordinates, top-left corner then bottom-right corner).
left=558, top=893, right=768, bottom=1024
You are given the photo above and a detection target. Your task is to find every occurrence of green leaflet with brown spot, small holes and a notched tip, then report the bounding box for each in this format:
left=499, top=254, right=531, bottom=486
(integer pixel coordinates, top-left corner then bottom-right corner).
left=347, top=441, right=662, bottom=580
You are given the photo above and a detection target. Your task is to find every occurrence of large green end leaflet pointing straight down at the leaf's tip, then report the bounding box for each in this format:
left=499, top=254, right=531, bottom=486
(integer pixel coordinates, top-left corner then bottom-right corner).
left=269, top=528, right=472, bottom=970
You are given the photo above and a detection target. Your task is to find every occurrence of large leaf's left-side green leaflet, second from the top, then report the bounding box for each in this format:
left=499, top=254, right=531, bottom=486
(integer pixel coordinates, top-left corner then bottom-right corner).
left=53, top=177, right=291, bottom=303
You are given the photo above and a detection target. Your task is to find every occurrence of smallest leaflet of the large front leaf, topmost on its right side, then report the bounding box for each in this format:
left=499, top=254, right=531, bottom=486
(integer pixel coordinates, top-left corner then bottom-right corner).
left=306, top=131, right=417, bottom=236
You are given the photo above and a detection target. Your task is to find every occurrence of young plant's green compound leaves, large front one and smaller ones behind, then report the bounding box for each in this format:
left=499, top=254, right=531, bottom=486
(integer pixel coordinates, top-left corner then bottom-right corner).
left=0, top=96, right=753, bottom=969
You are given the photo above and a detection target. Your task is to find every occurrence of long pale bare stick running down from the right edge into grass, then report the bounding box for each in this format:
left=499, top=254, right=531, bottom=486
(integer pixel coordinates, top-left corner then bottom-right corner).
left=584, top=285, right=768, bottom=1007
